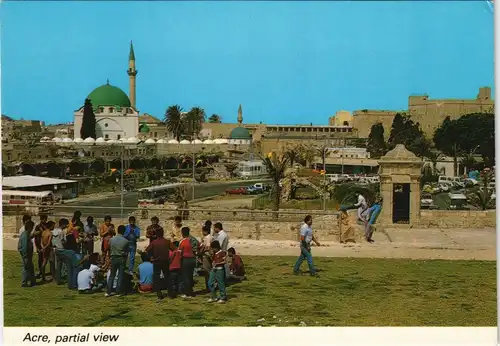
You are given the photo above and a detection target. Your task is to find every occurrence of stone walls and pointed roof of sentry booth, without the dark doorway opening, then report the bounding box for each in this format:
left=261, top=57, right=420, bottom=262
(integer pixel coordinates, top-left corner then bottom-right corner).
left=377, top=144, right=423, bottom=226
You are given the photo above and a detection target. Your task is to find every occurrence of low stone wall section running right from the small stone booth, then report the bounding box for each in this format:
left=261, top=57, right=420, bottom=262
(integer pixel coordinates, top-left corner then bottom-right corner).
left=415, top=210, right=496, bottom=228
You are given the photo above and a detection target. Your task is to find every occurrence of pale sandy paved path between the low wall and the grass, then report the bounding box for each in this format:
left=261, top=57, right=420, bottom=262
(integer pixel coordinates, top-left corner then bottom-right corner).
left=3, top=228, right=496, bottom=261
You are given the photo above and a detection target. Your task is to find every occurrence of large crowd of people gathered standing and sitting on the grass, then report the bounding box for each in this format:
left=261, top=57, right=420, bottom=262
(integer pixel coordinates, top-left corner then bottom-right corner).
left=18, top=211, right=245, bottom=303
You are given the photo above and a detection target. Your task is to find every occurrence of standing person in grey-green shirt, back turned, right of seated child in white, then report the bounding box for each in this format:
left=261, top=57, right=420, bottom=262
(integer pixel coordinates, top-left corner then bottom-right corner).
left=105, top=225, right=130, bottom=297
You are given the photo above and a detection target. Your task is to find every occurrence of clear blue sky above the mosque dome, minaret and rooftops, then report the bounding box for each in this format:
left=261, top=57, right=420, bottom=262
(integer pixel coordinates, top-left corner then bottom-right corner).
left=1, top=1, right=494, bottom=124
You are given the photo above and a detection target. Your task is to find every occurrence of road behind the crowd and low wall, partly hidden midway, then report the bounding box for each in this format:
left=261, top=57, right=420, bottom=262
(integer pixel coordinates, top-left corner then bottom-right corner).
left=55, top=180, right=263, bottom=217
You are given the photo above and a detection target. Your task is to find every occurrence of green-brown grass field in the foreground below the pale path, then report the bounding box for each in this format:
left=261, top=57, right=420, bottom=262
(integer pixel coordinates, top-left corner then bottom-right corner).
left=4, top=251, right=497, bottom=327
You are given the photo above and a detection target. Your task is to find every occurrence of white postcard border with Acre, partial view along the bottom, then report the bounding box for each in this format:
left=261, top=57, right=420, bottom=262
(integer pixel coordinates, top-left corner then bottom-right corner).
left=0, top=0, right=500, bottom=346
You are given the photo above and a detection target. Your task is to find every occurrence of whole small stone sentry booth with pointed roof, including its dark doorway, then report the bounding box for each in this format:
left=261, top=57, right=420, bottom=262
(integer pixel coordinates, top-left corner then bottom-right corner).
left=379, top=144, right=423, bottom=226
